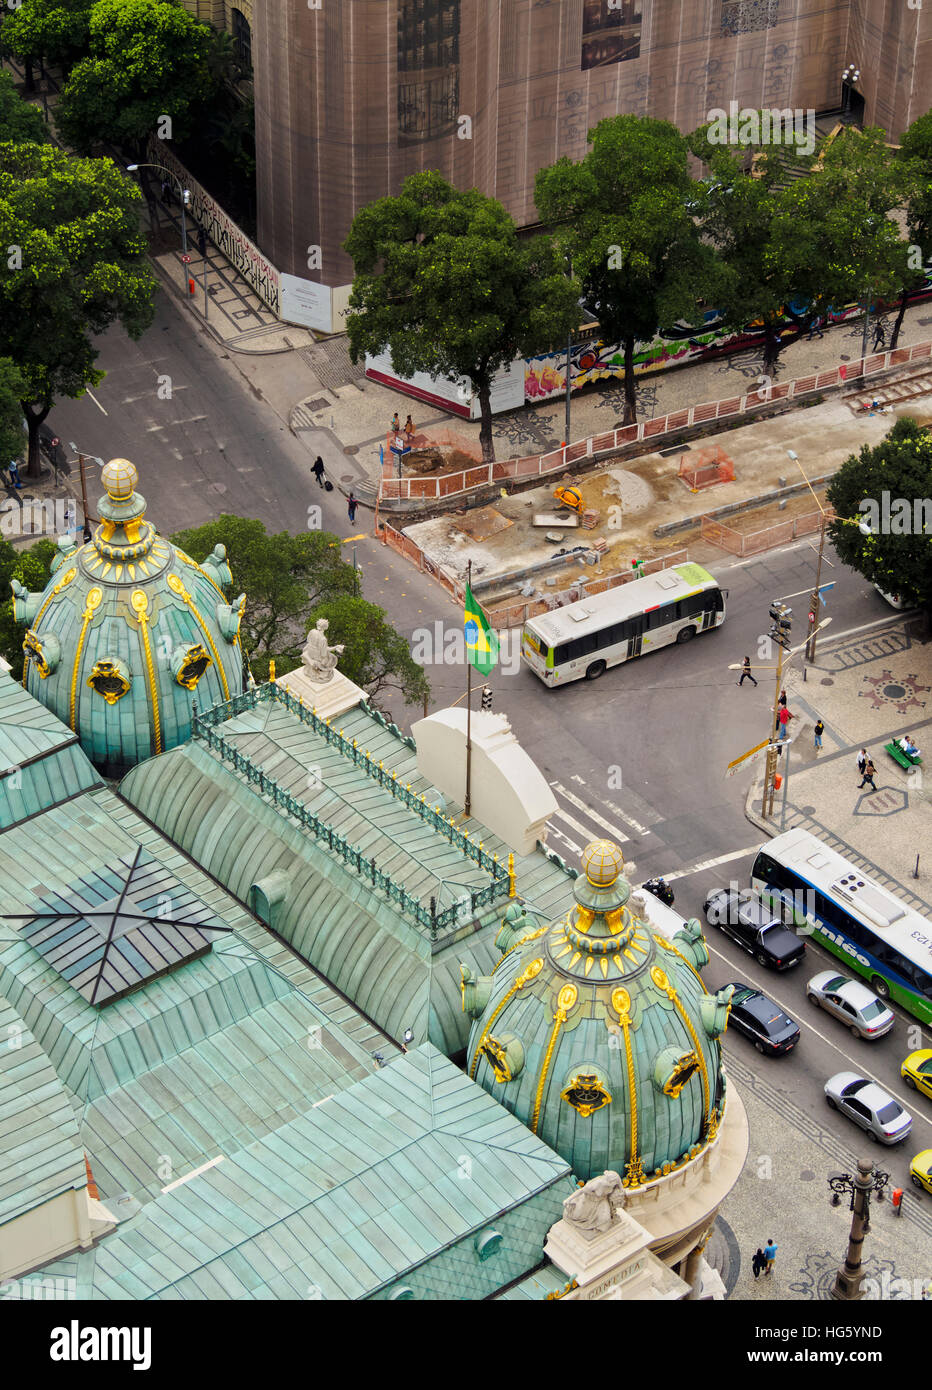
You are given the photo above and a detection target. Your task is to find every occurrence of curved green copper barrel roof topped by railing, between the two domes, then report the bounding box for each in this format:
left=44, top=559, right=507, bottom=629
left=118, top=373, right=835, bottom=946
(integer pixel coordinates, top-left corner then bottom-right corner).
left=121, top=687, right=572, bottom=1055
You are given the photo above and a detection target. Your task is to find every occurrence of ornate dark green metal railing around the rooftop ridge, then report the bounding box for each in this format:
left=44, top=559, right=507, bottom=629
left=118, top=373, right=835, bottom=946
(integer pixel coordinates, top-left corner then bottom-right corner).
left=192, top=684, right=511, bottom=941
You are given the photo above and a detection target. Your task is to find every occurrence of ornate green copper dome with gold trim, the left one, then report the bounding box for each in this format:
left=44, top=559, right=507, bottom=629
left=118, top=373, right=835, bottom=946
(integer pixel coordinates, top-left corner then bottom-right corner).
left=13, top=459, right=244, bottom=777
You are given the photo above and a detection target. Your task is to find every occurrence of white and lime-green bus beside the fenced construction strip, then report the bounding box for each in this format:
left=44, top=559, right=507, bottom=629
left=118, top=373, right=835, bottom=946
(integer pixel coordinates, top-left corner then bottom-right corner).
left=521, top=564, right=725, bottom=687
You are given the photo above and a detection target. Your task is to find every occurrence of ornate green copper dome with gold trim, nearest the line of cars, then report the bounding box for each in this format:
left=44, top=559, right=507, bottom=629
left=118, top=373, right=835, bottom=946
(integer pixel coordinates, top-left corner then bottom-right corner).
left=463, top=841, right=731, bottom=1187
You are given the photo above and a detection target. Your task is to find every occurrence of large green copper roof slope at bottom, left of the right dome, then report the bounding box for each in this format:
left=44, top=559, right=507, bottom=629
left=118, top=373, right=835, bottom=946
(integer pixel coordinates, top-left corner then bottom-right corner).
left=36, top=1045, right=574, bottom=1300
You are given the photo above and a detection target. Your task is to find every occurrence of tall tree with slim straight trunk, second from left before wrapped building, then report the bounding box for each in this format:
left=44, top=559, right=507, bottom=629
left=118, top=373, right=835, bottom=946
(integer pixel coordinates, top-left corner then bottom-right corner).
left=535, top=115, right=711, bottom=424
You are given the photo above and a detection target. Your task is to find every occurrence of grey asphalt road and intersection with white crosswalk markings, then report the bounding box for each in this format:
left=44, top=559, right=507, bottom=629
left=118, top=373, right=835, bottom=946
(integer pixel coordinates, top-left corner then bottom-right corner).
left=49, top=296, right=932, bottom=1186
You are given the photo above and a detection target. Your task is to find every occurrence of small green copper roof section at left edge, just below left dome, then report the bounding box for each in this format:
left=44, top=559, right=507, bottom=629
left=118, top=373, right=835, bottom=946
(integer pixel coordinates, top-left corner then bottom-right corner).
left=0, top=671, right=100, bottom=831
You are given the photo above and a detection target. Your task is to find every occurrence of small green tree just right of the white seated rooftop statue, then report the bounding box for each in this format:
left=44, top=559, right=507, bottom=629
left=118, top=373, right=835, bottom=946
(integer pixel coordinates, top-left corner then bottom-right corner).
left=308, top=595, right=431, bottom=706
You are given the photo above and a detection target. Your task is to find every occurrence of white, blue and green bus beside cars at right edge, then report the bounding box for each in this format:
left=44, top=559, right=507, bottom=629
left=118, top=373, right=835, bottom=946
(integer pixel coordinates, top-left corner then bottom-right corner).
left=751, top=830, right=932, bottom=1023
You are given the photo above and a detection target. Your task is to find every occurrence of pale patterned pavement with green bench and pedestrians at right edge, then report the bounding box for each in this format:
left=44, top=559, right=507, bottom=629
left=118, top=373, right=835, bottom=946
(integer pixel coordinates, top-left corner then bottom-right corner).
left=746, top=612, right=932, bottom=913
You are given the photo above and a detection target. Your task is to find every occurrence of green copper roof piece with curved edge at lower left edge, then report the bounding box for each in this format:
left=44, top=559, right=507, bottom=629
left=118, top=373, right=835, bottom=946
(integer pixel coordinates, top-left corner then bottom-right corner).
left=0, top=997, right=88, bottom=1238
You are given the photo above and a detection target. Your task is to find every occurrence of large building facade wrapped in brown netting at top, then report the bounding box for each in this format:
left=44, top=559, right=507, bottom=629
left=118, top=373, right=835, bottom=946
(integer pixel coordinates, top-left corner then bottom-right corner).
left=251, top=0, right=932, bottom=286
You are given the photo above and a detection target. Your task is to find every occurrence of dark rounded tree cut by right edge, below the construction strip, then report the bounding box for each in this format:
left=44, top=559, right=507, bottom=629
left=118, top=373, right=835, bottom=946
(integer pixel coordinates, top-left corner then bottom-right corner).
left=826, top=416, right=932, bottom=613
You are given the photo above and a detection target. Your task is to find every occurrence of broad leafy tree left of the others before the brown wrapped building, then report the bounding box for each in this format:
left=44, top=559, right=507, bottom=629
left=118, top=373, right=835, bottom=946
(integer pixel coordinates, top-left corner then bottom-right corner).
left=344, top=172, right=581, bottom=463
